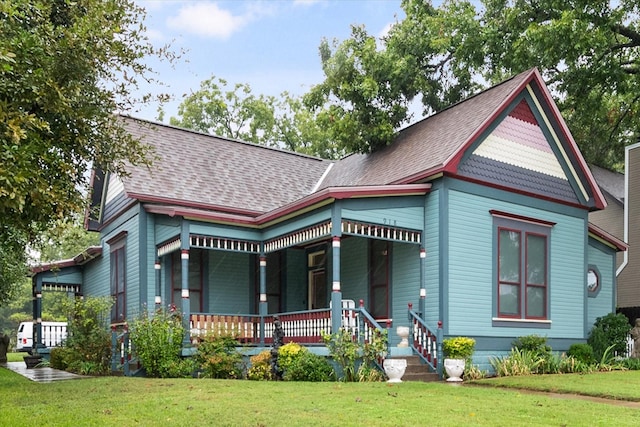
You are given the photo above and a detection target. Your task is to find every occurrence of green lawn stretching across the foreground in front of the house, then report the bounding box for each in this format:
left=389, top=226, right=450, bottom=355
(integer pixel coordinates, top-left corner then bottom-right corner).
left=0, top=368, right=640, bottom=427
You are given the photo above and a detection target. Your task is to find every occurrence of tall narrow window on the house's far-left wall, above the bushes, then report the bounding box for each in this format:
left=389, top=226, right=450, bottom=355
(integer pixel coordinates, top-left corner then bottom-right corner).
left=107, top=232, right=127, bottom=323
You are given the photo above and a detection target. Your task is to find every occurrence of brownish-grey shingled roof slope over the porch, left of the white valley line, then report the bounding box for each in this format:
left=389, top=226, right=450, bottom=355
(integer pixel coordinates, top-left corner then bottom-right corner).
left=117, top=117, right=331, bottom=214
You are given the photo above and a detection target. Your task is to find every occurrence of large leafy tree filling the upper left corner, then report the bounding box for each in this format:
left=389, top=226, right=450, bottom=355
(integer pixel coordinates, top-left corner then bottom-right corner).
left=0, top=0, right=175, bottom=304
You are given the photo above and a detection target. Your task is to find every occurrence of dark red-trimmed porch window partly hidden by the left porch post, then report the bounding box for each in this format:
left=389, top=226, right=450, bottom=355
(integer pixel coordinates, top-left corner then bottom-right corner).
left=171, top=249, right=204, bottom=313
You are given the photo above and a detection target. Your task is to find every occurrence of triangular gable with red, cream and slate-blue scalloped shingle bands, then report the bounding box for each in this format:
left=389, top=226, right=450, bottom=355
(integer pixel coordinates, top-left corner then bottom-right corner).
left=459, top=98, right=580, bottom=203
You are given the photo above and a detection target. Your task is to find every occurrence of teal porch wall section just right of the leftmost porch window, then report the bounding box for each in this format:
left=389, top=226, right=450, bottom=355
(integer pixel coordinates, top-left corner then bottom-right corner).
left=205, top=251, right=254, bottom=314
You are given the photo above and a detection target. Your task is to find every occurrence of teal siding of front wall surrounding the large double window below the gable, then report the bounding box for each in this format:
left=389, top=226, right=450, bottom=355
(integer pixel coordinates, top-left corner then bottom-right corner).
left=445, top=190, right=586, bottom=339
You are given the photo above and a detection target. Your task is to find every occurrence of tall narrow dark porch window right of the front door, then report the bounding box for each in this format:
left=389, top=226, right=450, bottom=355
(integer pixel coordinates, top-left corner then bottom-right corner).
left=369, top=240, right=390, bottom=319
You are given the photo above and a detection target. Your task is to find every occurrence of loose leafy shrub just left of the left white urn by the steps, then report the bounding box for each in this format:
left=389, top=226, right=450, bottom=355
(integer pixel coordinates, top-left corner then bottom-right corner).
left=322, top=328, right=387, bottom=382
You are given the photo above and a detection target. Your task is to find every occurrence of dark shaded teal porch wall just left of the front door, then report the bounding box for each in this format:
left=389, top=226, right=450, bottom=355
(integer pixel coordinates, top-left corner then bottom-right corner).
left=284, top=249, right=309, bottom=311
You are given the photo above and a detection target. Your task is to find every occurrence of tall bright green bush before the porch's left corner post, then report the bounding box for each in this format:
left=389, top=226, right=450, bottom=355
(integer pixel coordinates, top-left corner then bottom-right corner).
left=130, top=309, right=184, bottom=378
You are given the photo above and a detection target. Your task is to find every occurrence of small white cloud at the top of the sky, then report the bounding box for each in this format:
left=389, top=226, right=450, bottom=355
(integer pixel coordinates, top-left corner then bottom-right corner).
left=167, top=2, right=254, bottom=39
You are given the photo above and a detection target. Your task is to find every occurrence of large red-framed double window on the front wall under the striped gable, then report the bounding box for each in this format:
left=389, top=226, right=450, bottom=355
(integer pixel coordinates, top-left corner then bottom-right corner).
left=495, top=211, right=550, bottom=320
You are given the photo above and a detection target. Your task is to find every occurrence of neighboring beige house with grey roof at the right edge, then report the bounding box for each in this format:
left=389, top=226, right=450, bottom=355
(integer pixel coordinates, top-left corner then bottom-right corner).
left=589, top=142, right=640, bottom=324
